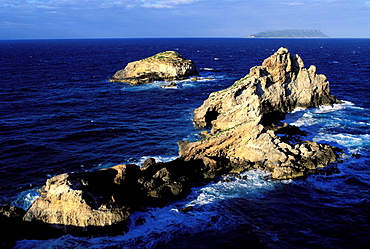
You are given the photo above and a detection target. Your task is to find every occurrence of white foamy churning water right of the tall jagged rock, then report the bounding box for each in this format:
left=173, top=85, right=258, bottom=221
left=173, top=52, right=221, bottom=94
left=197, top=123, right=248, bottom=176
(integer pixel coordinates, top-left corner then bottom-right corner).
left=284, top=98, right=370, bottom=156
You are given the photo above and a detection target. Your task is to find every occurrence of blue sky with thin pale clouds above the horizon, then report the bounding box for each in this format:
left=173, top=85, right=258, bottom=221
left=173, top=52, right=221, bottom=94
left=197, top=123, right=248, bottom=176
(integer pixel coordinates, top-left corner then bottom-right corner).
left=0, top=0, right=370, bottom=40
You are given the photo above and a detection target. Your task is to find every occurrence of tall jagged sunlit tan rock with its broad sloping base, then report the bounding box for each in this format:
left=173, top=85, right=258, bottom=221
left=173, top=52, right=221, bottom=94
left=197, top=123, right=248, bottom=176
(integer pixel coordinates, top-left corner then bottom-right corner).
left=179, top=48, right=338, bottom=179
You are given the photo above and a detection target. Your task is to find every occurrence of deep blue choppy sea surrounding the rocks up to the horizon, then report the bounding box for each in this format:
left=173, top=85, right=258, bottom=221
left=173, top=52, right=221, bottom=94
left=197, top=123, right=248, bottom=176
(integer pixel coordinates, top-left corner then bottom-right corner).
left=0, top=38, right=370, bottom=248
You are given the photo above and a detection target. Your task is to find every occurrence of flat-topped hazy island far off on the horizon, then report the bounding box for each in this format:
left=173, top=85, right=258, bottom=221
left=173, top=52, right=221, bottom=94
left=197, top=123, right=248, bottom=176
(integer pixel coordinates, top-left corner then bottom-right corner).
left=246, top=29, right=329, bottom=38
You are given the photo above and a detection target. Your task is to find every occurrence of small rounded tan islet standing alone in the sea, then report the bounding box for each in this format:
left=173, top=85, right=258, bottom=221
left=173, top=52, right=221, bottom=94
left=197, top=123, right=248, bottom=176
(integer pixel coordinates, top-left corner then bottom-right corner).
left=110, top=51, right=198, bottom=85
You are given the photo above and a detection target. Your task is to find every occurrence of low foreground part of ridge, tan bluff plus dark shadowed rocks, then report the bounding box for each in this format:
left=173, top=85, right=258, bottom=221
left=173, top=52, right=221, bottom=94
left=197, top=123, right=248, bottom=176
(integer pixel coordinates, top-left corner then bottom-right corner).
left=23, top=159, right=208, bottom=233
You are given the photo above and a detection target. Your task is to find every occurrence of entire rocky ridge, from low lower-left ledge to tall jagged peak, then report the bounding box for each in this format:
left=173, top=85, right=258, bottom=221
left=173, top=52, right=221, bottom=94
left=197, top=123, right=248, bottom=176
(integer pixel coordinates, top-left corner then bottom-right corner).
left=0, top=48, right=341, bottom=244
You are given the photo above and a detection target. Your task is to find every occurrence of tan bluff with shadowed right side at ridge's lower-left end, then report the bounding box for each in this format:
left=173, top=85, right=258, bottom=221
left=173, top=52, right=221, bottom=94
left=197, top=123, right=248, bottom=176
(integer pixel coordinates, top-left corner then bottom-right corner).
left=23, top=165, right=140, bottom=231
